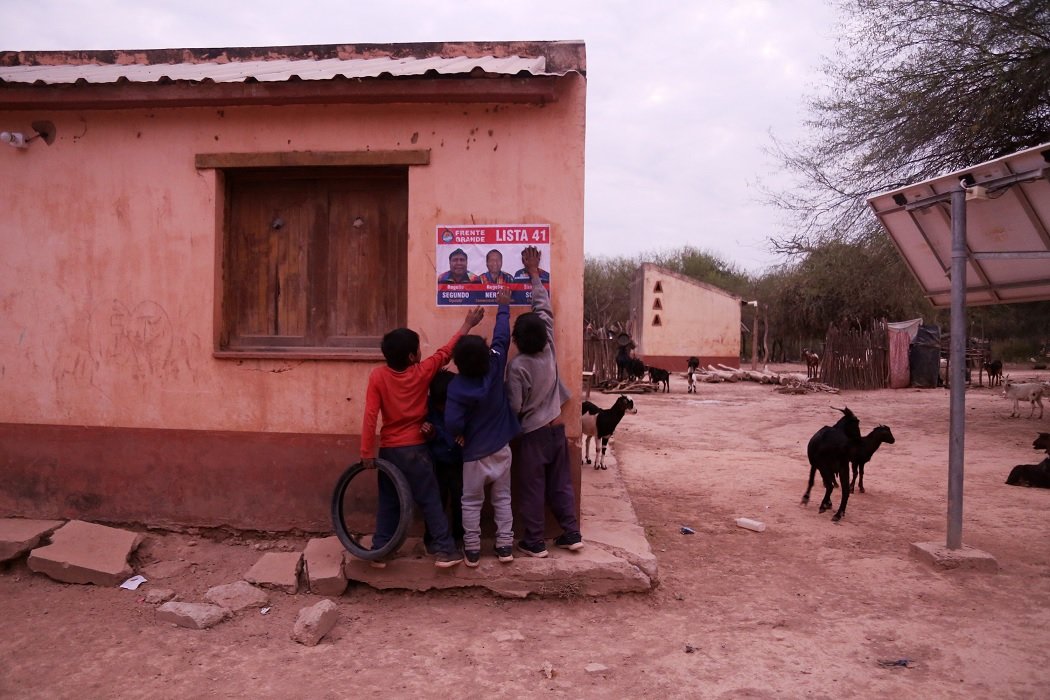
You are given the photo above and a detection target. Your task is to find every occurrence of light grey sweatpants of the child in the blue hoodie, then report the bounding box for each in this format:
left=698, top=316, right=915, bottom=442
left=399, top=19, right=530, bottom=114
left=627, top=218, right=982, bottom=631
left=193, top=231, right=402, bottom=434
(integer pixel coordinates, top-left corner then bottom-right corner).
left=463, top=445, right=515, bottom=550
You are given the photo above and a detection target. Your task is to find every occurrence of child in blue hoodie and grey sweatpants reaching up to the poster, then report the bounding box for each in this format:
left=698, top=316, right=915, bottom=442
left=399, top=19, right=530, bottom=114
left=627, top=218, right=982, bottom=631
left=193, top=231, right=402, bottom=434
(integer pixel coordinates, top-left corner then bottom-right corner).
left=445, top=289, right=521, bottom=567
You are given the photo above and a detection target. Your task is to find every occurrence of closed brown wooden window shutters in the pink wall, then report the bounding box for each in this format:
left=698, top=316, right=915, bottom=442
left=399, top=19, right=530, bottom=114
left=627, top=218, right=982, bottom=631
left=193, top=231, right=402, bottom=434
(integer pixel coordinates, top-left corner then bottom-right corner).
left=219, top=166, right=408, bottom=353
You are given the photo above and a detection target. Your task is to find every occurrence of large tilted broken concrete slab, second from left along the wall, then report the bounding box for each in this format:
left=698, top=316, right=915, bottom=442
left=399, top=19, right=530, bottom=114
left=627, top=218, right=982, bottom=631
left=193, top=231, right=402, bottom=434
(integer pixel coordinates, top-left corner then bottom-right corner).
left=27, top=521, right=144, bottom=586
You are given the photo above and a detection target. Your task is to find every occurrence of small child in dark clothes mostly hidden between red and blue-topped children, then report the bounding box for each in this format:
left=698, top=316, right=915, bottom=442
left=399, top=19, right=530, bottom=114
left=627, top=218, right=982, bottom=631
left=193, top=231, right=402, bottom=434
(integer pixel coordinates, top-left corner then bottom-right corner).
left=423, top=369, right=463, bottom=549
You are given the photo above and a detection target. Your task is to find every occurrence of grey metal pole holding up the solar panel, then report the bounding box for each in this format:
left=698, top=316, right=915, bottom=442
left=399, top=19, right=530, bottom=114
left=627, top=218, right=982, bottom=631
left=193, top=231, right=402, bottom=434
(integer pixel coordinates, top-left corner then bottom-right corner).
left=947, top=183, right=966, bottom=549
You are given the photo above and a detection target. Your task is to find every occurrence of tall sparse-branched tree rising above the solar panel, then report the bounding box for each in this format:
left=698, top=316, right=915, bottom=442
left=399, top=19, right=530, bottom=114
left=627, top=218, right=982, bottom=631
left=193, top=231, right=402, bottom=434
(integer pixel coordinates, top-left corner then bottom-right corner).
left=771, top=0, right=1050, bottom=253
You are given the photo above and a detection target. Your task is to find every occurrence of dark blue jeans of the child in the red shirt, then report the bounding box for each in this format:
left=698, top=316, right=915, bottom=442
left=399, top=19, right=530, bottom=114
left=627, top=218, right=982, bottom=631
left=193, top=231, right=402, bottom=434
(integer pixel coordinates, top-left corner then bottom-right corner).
left=372, top=445, right=456, bottom=554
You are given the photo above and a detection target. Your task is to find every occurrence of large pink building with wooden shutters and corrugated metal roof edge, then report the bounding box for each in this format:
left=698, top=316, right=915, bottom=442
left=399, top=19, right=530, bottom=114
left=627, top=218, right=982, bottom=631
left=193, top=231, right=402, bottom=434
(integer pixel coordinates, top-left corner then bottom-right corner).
left=0, top=42, right=586, bottom=532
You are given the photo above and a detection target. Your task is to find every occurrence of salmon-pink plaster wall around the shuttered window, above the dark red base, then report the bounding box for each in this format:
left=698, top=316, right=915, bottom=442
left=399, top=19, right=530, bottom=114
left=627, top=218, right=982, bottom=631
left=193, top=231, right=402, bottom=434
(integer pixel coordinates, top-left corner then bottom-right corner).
left=0, top=75, right=585, bottom=528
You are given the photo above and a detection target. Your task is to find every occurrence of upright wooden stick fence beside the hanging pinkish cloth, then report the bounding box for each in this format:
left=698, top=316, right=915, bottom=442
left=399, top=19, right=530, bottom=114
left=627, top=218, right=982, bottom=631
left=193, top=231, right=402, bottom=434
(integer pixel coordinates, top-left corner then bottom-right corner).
left=820, top=320, right=889, bottom=389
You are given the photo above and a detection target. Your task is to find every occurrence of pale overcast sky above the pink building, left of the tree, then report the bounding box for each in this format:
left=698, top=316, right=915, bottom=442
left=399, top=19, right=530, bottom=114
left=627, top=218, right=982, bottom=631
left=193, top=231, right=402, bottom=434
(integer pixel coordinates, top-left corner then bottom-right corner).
left=0, top=0, right=835, bottom=272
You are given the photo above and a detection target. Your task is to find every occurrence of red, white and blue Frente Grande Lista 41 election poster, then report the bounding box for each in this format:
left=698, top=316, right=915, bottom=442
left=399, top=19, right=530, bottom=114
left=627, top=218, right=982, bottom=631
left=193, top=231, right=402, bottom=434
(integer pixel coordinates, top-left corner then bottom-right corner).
left=436, top=224, right=550, bottom=306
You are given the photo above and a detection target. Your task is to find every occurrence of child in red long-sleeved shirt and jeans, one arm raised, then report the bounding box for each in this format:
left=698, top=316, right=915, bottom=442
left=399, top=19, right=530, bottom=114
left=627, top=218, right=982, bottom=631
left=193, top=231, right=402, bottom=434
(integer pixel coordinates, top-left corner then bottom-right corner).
left=361, top=306, right=485, bottom=568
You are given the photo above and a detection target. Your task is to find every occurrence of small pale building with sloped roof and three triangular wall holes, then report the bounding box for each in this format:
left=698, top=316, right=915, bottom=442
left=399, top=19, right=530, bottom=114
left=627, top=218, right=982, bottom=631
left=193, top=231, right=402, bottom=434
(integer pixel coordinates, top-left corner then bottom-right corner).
left=630, top=262, right=741, bottom=372
